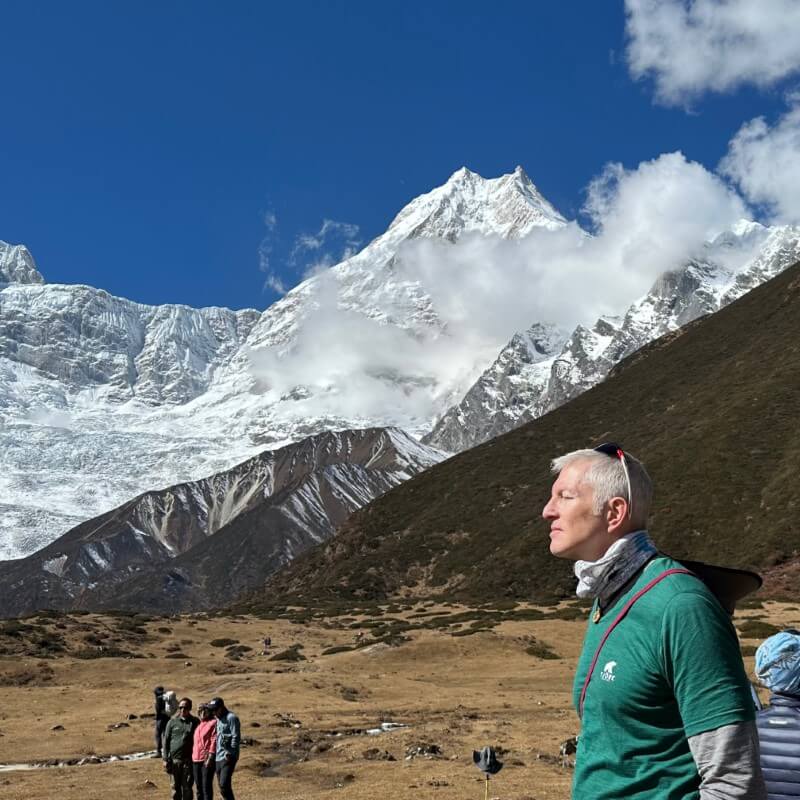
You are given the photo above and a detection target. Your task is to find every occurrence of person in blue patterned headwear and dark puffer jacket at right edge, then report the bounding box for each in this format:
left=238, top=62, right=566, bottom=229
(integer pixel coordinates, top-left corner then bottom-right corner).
left=756, top=629, right=800, bottom=800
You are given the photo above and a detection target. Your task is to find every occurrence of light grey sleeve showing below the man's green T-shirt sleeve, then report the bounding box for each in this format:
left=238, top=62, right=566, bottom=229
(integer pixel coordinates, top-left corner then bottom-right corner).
left=689, top=722, right=767, bottom=800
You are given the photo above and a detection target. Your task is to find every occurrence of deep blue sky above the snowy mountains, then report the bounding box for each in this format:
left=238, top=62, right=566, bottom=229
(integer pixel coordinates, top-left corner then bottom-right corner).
left=0, top=0, right=796, bottom=308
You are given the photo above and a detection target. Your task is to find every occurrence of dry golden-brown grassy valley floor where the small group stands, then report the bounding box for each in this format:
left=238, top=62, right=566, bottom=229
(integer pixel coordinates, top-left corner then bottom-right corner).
left=0, top=602, right=800, bottom=800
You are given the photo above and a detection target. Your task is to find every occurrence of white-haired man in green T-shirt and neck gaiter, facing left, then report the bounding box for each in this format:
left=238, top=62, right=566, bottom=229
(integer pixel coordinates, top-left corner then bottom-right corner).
left=542, top=444, right=766, bottom=800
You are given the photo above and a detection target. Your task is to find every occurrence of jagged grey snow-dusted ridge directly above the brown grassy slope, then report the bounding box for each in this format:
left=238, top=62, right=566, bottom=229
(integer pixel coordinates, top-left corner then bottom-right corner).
left=424, top=220, right=800, bottom=452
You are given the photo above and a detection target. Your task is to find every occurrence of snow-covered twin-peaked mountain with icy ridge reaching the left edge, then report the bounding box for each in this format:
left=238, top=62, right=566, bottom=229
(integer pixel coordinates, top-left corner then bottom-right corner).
left=0, top=168, right=565, bottom=558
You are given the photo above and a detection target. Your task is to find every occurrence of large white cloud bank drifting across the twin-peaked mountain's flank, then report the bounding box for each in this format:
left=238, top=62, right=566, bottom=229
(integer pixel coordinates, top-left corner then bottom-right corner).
left=245, top=153, right=746, bottom=426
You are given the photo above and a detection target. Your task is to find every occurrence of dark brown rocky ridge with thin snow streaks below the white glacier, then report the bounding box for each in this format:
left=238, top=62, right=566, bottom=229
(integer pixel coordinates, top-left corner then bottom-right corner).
left=0, top=428, right=445, bottom=616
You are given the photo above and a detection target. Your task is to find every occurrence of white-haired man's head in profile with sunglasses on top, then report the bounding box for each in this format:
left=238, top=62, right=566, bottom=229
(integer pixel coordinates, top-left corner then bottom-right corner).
left=542, top=445, right=653, bottom=561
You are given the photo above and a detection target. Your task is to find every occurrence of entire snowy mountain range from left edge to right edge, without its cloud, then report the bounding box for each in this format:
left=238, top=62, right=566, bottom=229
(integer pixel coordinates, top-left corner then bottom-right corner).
left=6, top=167, right=800, bottom=558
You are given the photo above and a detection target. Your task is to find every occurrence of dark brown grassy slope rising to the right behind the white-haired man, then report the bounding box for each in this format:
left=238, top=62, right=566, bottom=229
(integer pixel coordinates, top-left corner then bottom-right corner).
left=245, top=265, right=800, bottom=609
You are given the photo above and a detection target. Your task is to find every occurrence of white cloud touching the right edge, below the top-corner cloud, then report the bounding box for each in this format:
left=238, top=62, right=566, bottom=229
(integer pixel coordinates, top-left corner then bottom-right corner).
left=720, top=102, right=800, bottom=223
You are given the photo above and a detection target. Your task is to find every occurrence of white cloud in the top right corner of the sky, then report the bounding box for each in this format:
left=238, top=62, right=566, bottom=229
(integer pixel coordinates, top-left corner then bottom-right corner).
left=625, top=0, right=800, bottom=104
